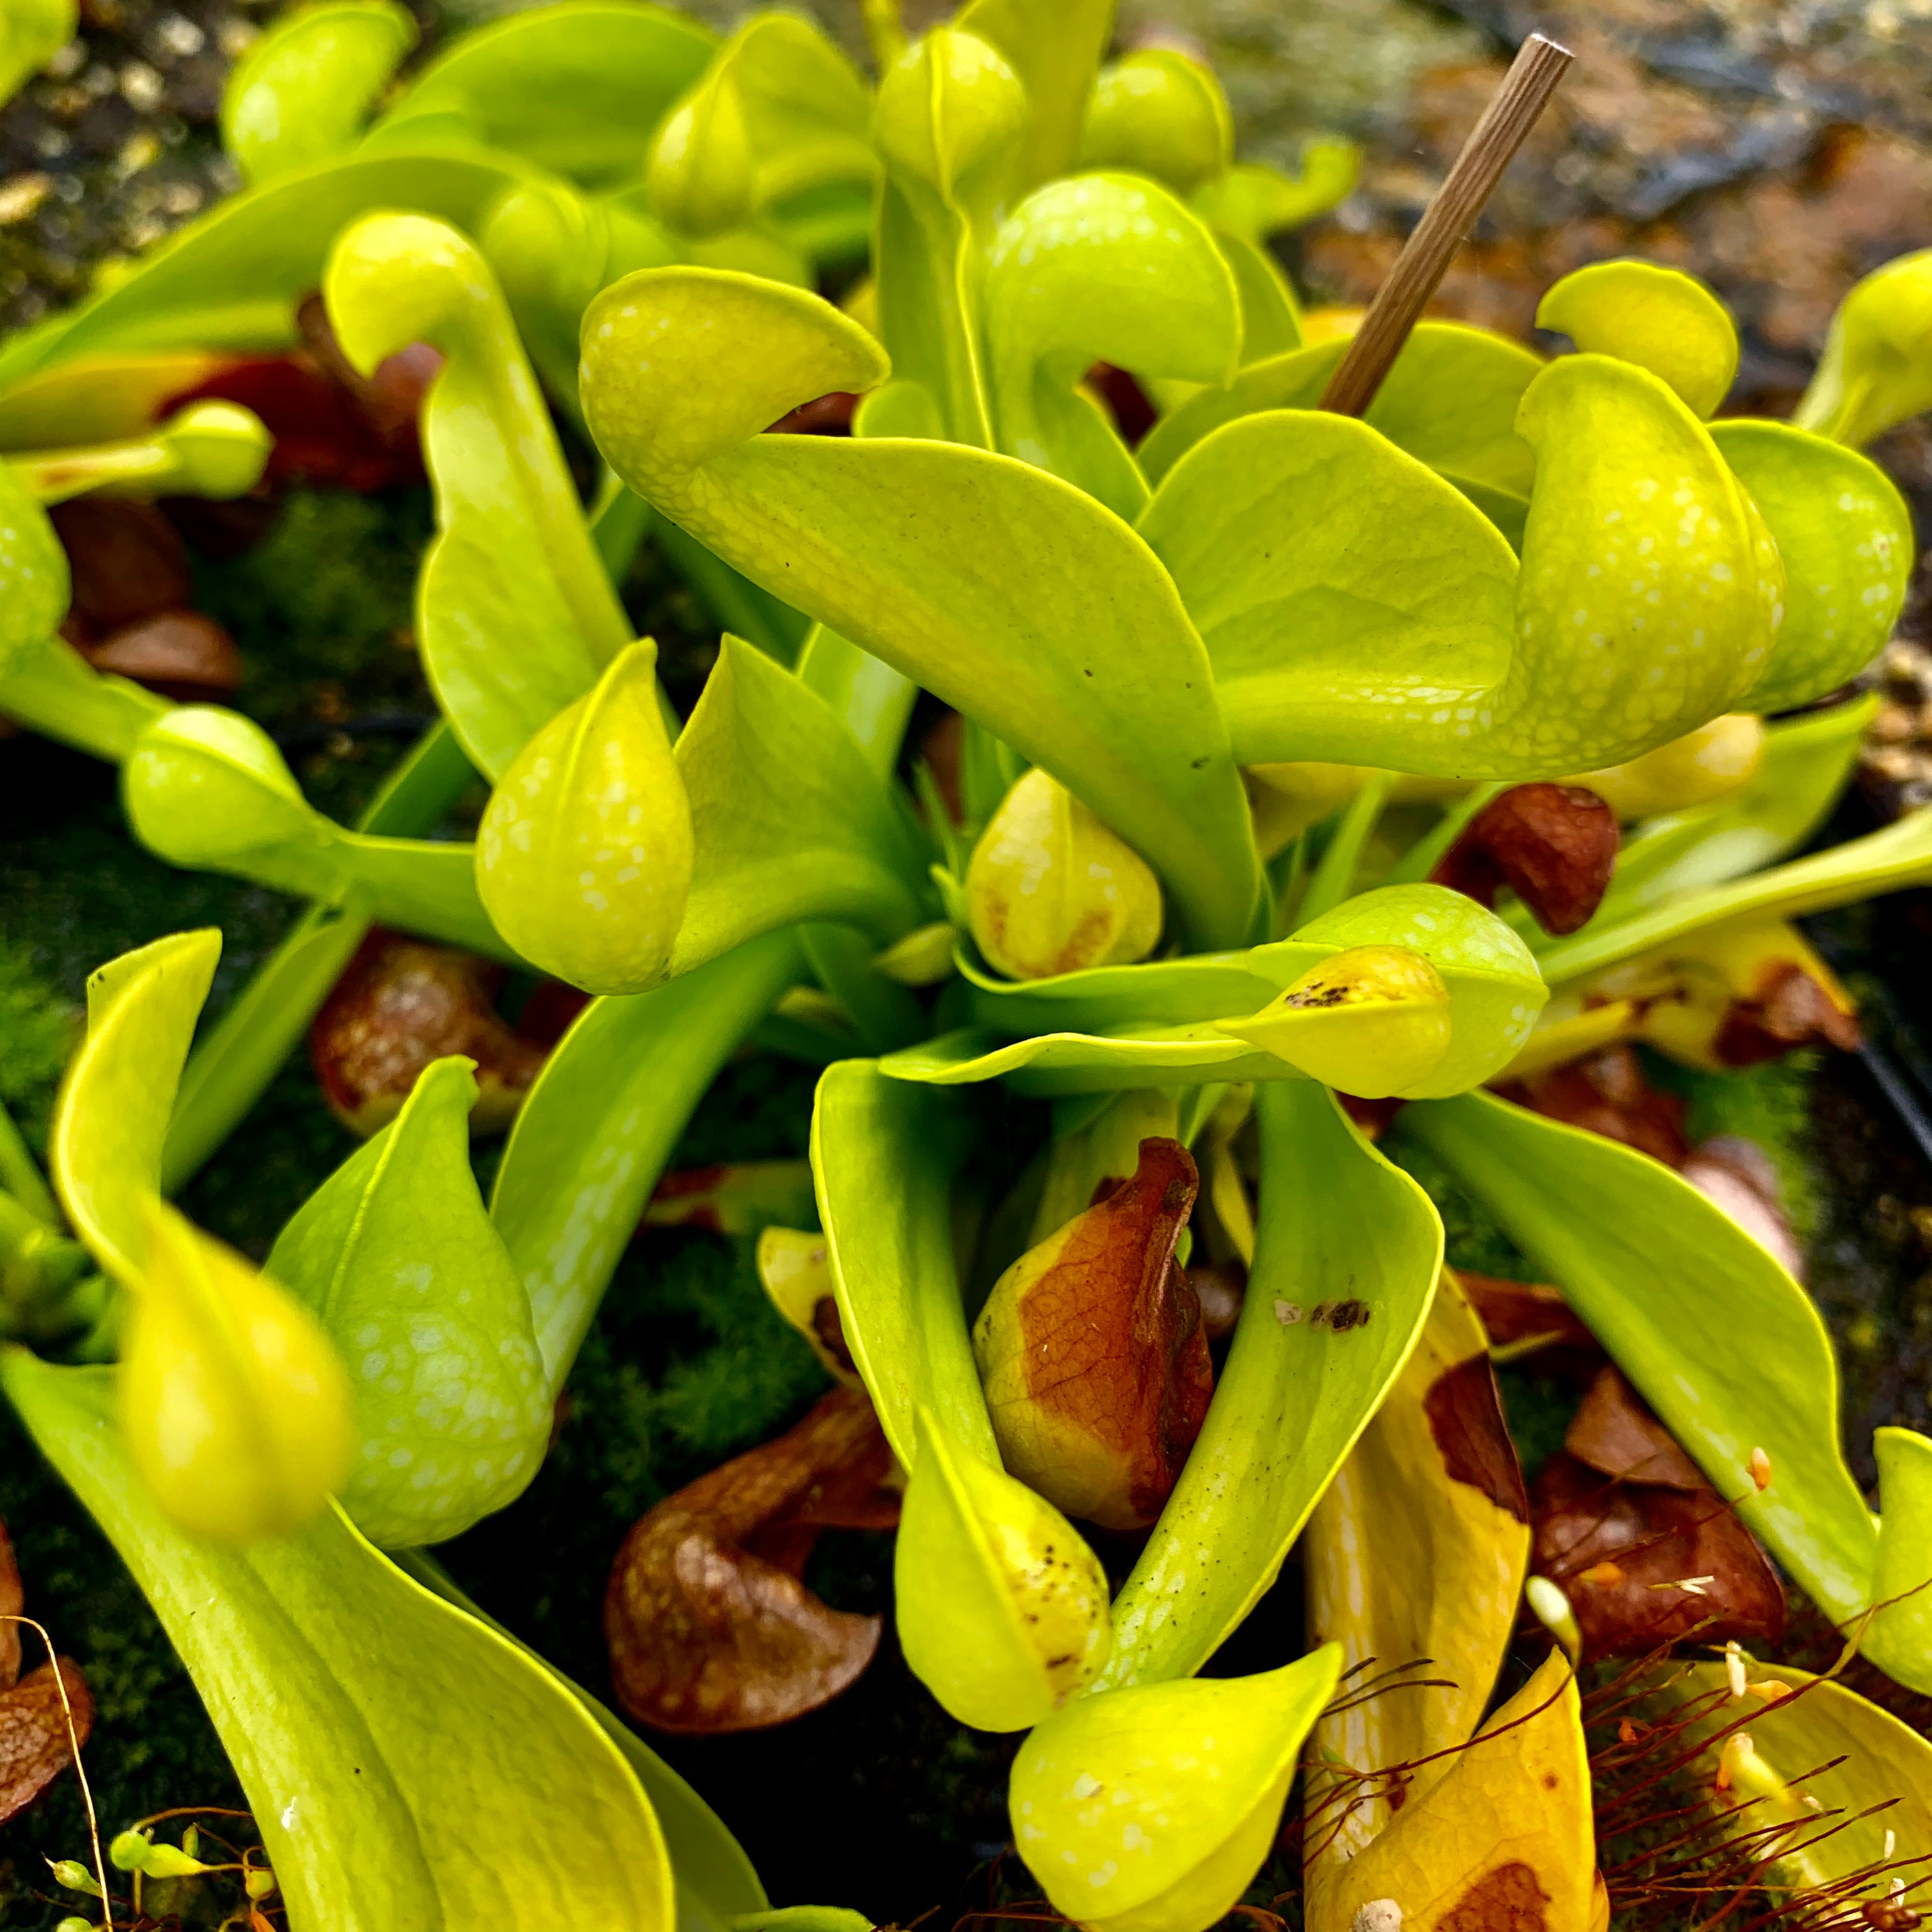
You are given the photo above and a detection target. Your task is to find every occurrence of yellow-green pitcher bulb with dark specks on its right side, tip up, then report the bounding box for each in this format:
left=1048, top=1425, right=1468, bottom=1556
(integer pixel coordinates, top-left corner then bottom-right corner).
left=893, top=1408, right=1113, bottom=1731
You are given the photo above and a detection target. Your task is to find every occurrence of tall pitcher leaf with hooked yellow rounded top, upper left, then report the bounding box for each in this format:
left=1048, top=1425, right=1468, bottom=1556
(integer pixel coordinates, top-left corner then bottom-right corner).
left=323, top=215, right=632, bottom=779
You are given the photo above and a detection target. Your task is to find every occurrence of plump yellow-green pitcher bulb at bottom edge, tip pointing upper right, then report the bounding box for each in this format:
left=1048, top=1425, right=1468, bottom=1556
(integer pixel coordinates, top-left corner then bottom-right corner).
left=1007, top=1644, right=1341, bottom=1932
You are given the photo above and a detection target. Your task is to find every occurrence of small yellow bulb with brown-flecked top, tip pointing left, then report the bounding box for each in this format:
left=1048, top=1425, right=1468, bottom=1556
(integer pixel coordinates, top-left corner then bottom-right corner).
left=1215, top=947, right=1449, bottom=1100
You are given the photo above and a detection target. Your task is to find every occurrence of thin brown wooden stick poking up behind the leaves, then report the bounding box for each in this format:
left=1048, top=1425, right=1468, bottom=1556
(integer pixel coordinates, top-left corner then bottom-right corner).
left=1321, top=33, right=1577, bottom=415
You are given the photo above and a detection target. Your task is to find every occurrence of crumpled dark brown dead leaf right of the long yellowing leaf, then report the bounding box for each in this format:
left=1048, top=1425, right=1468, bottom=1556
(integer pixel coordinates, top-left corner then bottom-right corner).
left=1532, top=1449, right=1785, bottom=1658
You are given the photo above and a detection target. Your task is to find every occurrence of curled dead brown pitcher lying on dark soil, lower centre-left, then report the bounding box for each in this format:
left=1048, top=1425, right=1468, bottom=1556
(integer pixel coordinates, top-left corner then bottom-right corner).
left=602, top=1389, right=898, bottom=1733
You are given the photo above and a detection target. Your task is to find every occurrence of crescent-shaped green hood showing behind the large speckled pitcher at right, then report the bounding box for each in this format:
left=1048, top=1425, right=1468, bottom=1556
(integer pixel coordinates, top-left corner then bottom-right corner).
left=1710, top=421, right=1917, bottom=711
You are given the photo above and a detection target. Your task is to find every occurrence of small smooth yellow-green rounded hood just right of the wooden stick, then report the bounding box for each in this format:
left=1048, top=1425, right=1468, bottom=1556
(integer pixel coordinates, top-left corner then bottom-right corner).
left=1536, top=261, right=1737, bottom=415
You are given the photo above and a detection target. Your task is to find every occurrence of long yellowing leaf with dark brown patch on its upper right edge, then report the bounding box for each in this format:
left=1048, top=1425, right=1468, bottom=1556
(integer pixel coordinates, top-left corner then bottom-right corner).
left=1302, top=1269, right=1530, bottom=1860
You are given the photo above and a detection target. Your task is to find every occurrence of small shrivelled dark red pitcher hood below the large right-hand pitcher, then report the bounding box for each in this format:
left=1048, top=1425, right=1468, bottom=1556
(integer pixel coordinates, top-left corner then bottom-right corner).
left=1430, top=785, right=1619, bottom=933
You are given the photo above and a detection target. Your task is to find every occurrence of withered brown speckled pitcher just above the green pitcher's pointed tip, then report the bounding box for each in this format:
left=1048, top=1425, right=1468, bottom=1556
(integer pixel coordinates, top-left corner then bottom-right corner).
left=309, top=928, right=545, bottom=1134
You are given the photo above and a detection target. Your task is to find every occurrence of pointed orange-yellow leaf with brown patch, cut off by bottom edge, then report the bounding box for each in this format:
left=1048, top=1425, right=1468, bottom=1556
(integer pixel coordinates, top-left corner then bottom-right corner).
left=1308, top=1650, right=1596, bottom=1932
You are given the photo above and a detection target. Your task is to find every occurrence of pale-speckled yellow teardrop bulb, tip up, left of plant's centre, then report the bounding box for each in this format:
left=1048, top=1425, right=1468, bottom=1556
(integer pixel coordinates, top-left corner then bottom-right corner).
left=477, top=640, right=694, bottom=993
